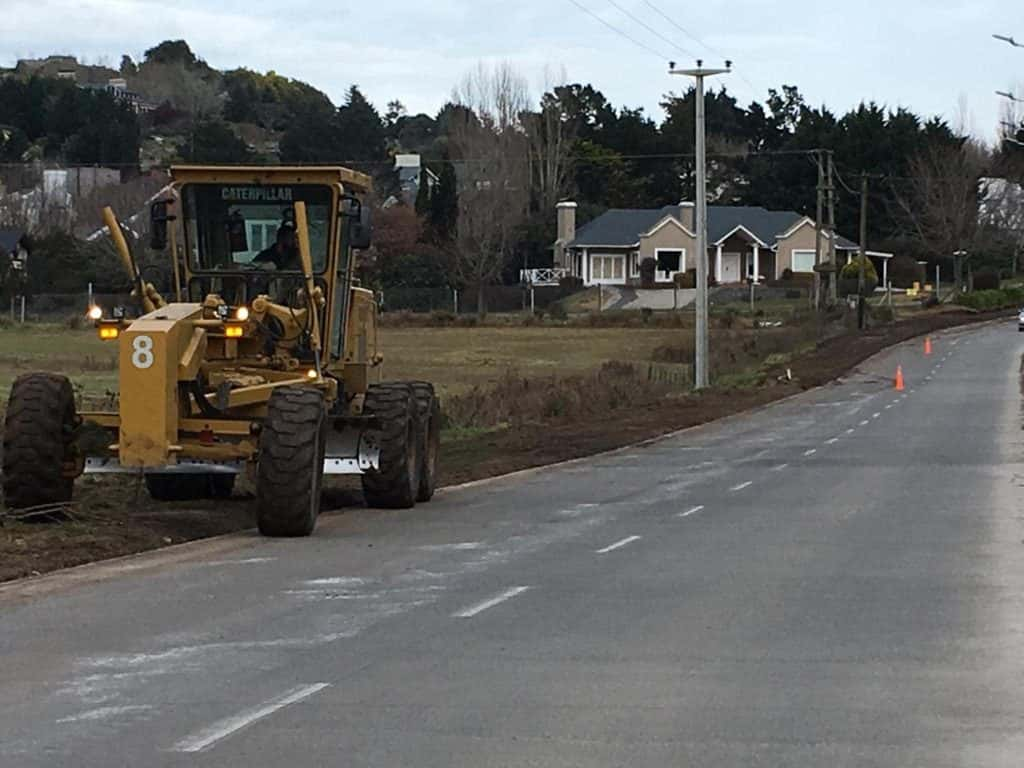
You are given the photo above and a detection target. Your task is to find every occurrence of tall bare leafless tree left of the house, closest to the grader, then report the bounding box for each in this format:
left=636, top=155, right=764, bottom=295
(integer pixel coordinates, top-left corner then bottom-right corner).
left=449, top=63, right=529, bottom=314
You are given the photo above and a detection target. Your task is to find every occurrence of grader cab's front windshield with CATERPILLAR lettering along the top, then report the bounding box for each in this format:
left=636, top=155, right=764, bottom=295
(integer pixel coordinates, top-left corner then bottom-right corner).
left=182, top=184, right=332, bottom=272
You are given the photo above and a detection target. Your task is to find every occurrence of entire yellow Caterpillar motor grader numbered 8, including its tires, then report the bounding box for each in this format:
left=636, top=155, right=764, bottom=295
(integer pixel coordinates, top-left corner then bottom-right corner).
left=3, top=166, right=440, bottom=536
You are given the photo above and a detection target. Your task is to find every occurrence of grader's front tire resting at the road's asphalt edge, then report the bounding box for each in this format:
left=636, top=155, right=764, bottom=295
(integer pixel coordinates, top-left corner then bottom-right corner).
left=256, top=387, right=327, bottom=537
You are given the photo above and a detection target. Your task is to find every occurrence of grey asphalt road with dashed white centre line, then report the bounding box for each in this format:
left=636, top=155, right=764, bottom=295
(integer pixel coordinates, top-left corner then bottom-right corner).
left=0, top=324, right=1024, bottom=768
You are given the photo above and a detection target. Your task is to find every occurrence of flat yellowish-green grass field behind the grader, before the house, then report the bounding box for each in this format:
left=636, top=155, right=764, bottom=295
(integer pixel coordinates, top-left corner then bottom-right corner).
left=0, top=325, right=692, bottom=398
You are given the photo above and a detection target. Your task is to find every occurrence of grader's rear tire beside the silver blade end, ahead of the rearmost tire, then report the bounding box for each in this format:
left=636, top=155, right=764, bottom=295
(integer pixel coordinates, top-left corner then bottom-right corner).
left=362, top=384, right=421, bottom=509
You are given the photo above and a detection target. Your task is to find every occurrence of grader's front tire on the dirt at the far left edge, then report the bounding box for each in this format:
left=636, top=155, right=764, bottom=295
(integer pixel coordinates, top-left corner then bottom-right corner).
left=3, top=374, right=78, bottom=509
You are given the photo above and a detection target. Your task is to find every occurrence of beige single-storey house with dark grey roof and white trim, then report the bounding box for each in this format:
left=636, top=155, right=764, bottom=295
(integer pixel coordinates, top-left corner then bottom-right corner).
left=555, top=202, right=892, bottom=286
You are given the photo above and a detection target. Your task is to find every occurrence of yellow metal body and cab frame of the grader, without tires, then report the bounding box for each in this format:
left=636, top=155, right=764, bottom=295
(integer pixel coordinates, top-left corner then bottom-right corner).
left=90, top=166, right=382, bottom=468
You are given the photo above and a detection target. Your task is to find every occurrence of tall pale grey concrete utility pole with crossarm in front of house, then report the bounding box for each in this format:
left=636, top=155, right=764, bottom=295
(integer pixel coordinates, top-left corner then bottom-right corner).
left=669, top=58, right=732, bottom=389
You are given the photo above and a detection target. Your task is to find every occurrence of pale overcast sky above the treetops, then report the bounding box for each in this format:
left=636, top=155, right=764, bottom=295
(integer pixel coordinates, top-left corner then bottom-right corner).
left=0, top=0, right=1024, bottom=140
